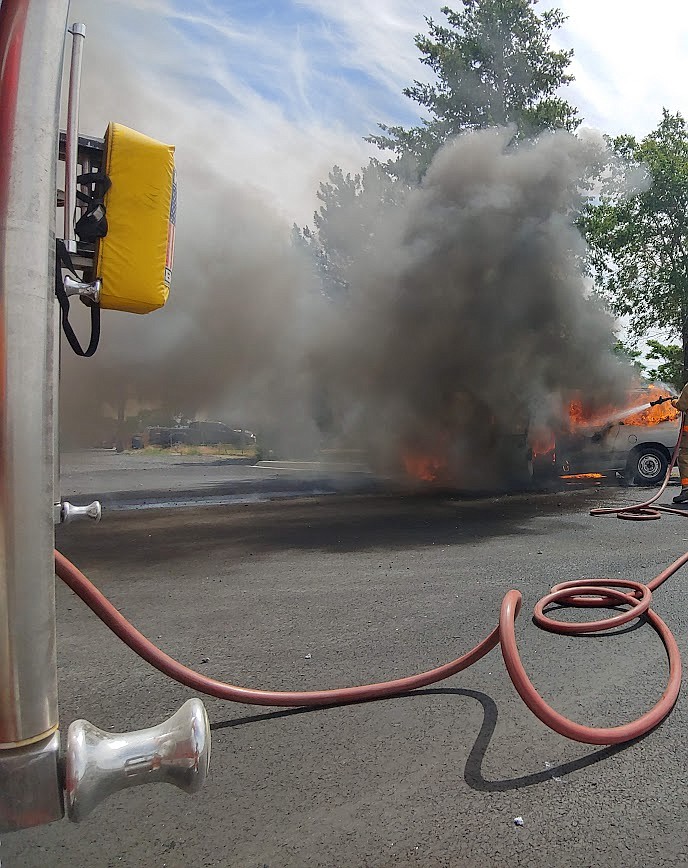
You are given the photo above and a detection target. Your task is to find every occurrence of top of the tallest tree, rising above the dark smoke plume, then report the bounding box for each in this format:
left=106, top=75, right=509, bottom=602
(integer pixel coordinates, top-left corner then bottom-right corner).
left=367, top=0, right=580, bottom=176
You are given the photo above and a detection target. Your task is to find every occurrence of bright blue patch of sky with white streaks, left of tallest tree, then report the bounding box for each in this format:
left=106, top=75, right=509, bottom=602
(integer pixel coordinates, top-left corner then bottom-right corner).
left=163, top=0, right=424, bottom=129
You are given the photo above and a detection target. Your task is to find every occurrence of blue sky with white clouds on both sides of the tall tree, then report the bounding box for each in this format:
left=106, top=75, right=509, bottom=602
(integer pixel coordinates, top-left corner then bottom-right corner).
left=71, top=0, right=688, bottom=222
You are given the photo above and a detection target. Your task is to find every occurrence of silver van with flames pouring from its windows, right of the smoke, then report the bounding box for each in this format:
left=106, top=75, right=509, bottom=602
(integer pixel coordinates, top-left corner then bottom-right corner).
left=550, top=386, right=681, bottom=485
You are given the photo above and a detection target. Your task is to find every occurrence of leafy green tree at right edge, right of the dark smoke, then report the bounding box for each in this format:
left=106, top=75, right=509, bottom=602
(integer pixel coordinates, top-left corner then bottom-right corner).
left=581, top=109, right=688, bottom=387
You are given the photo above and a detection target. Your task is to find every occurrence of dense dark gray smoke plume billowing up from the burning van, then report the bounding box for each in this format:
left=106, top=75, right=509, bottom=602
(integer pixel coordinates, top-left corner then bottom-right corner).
left=318, top=129, right=629, bottom=480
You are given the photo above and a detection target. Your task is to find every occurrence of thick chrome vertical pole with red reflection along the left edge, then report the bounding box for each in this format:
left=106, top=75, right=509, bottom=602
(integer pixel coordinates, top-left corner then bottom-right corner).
left=0, top=0, right=69, bottom=832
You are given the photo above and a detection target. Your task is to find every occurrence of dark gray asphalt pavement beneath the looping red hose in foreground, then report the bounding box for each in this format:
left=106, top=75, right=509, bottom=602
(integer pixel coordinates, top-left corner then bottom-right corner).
left=5, top=458, right=688, bottom=868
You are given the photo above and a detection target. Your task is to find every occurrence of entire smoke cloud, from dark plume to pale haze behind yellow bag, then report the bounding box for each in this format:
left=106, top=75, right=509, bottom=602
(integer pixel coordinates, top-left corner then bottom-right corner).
left=62, top=4, right=628, bottom=482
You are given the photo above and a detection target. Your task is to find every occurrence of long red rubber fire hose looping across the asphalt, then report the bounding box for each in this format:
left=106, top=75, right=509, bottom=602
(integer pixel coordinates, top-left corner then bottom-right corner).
left=55, top=414, right=688, bottom=744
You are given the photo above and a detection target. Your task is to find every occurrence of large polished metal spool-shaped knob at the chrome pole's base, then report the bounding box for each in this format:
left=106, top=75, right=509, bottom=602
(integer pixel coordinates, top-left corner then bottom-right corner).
left=64, top=699, right=210, bottom=823
